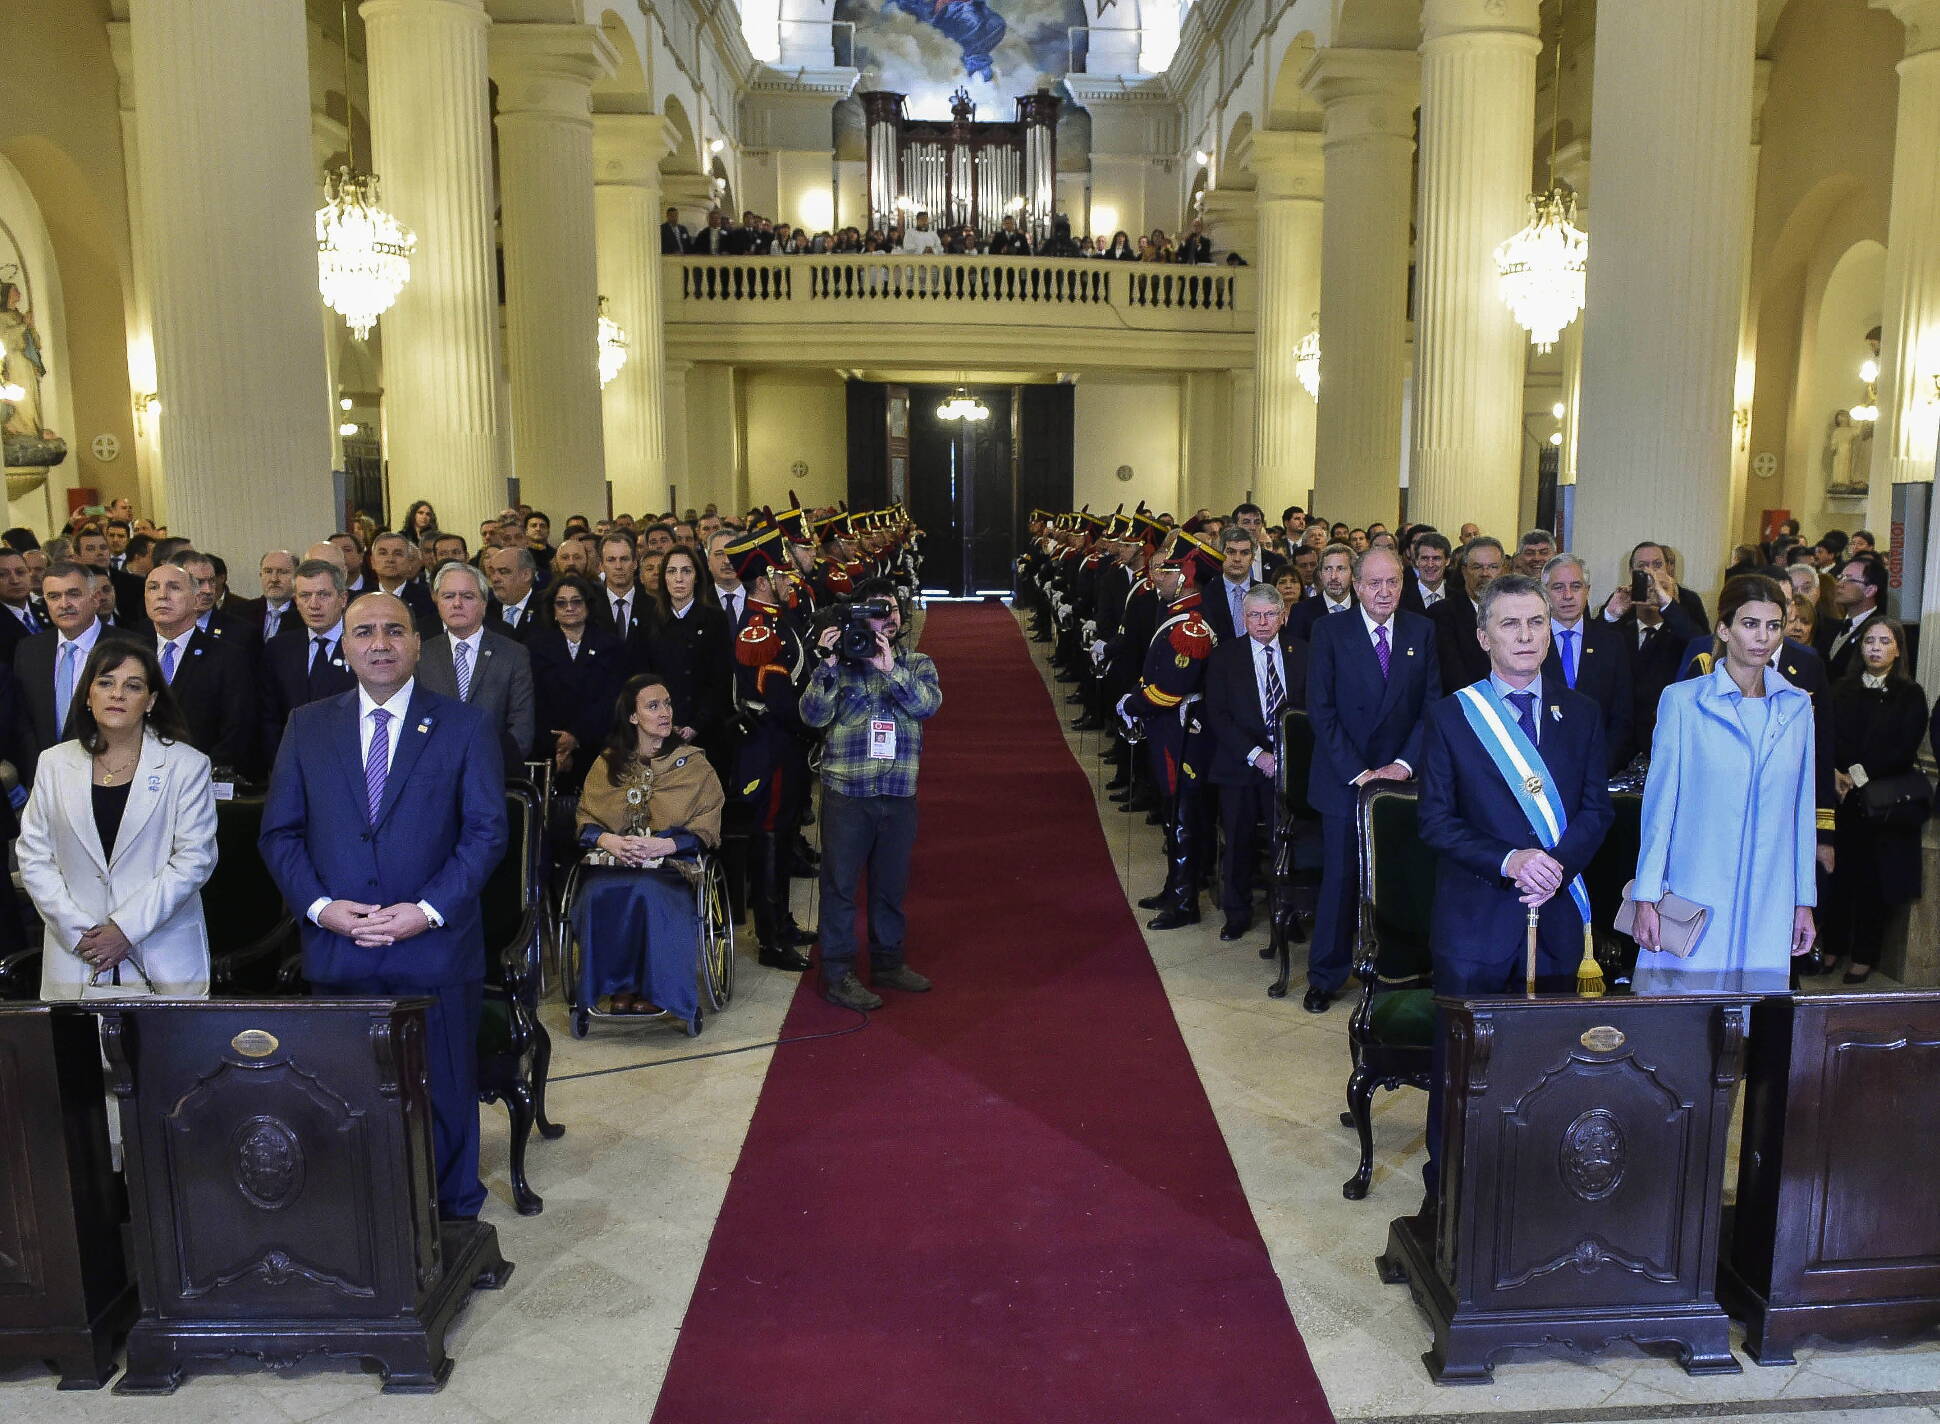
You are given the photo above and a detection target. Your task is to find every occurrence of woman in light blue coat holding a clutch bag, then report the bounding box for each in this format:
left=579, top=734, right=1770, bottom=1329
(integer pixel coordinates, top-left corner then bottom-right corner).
left=1632, top=574, right=1818, bottom=987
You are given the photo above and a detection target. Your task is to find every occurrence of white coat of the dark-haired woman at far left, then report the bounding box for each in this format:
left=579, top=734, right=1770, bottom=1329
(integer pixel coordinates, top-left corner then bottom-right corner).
left=17, top=733, right=215, bottom=999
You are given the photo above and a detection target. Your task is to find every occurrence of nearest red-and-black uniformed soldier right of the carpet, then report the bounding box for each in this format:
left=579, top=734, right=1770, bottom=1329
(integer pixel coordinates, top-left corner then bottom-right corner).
left=1117, top=530, right=1220, bottom=929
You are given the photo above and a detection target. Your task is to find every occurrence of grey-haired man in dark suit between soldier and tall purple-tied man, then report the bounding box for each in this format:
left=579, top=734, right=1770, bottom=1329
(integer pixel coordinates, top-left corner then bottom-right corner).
left=1201, top=584, right=1308, bottom=943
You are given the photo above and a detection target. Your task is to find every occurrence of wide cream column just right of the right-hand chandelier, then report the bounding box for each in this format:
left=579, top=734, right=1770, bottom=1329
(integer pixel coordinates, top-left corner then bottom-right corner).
left=1573, top=0, right=1758, bottom=605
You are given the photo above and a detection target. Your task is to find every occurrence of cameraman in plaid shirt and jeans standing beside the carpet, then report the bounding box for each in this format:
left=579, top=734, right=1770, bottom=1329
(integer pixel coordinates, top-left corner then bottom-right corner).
left=801, top=580, right=943, bottom=1009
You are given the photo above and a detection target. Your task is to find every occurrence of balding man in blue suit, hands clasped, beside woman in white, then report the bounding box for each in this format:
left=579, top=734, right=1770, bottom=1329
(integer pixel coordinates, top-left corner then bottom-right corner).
left=260, top=594, right=506, bottom=1218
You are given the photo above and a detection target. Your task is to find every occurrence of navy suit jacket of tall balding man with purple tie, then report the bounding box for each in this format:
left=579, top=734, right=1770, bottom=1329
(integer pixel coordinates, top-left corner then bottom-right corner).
left=1308, top=609, right=1441, bottom=817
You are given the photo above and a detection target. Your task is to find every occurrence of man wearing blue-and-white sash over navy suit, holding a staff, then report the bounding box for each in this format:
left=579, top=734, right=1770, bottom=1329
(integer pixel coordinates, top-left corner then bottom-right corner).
left=1418, top=574, right=1612, bottom=1203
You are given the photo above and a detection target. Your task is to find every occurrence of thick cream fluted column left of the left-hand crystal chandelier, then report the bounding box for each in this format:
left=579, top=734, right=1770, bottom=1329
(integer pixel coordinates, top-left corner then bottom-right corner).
left=130, top=0, right=336, bottom=570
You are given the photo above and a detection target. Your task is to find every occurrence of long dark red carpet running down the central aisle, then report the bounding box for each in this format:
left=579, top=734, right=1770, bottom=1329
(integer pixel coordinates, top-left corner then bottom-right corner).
left=654, top=605, right=1333, bottom=1424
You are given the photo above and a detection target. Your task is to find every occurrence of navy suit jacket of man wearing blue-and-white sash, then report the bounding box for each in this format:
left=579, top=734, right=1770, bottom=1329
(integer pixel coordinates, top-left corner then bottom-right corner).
left=1416, top=673, right=1614, bottom=974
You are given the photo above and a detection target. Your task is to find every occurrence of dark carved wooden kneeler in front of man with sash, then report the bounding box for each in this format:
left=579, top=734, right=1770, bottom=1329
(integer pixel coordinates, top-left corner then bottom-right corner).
left=1377, top=972, right=1785, bottom=1383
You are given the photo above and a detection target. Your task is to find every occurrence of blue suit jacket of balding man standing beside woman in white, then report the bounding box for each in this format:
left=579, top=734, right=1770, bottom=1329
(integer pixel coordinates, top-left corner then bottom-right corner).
left=258, top=687, right=506, bottom=989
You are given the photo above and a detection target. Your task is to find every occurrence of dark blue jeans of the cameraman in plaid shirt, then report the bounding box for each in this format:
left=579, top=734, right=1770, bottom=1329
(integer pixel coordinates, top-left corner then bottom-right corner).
left=819, top=786, right=916, bottom=984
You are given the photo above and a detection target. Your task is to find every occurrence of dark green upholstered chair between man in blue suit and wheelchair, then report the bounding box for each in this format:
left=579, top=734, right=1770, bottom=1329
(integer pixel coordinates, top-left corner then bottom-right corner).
left=477, top=780, right=565, bottom=1216
